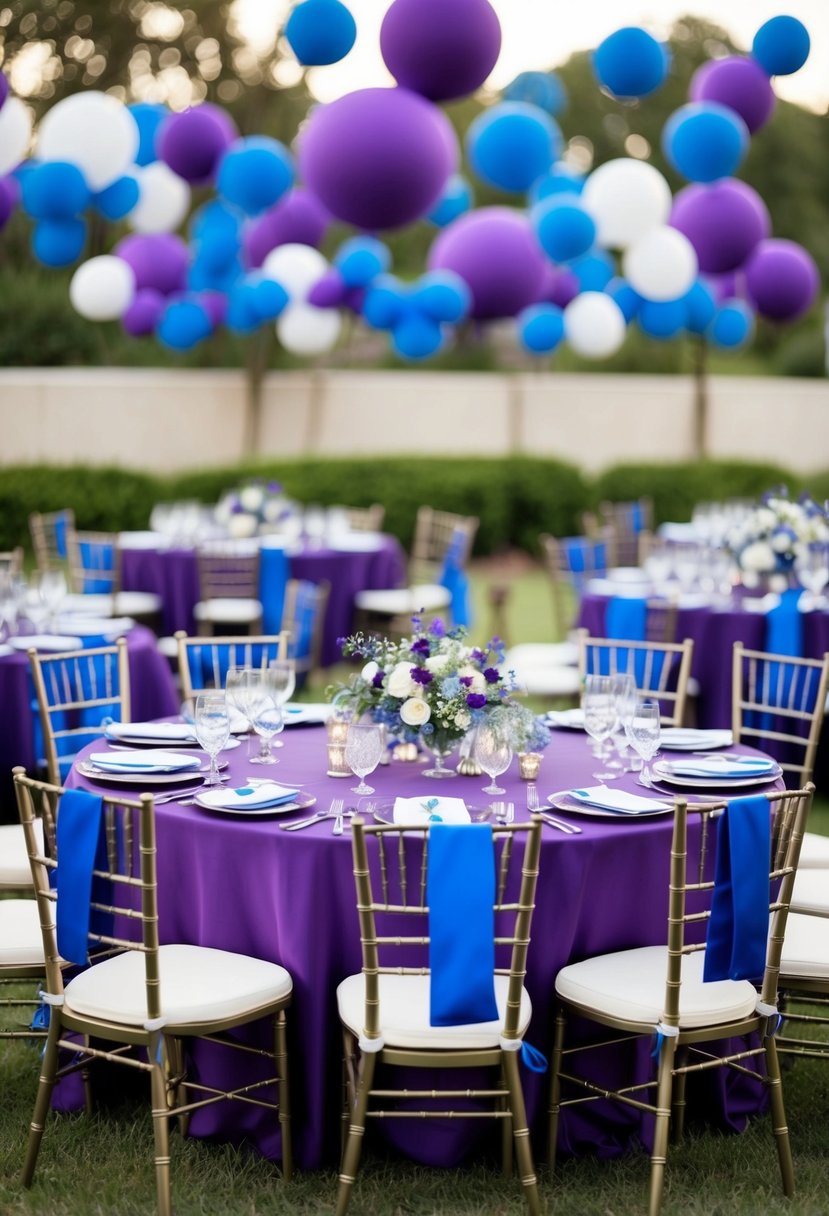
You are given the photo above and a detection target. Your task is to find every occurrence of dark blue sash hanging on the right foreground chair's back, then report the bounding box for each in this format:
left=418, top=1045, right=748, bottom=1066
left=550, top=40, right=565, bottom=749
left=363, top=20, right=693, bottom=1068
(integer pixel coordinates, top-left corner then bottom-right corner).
left=703, top=795, right=772, bottom=980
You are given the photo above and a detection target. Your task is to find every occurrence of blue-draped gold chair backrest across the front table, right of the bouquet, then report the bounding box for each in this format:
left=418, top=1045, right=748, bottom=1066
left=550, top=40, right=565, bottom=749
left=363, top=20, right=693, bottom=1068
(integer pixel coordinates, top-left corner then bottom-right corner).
left=579, top=629, right=694, bottom=726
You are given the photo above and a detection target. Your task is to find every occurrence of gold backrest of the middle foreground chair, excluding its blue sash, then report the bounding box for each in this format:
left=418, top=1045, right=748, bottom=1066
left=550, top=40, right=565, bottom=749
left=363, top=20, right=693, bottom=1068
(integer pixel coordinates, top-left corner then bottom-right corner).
left=351, top=817, right=541, bottom=1038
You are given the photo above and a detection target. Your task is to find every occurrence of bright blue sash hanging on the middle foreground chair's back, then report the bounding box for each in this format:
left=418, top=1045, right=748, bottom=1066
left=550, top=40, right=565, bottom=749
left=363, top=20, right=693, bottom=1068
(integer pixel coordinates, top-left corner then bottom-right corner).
left=427, top=823, right=498, bottom=1026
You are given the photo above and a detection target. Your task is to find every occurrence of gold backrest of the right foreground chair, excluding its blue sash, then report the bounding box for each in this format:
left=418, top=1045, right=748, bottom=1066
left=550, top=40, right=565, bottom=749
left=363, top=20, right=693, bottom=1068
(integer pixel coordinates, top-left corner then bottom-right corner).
left=662, top=784, right=814, bottom=1026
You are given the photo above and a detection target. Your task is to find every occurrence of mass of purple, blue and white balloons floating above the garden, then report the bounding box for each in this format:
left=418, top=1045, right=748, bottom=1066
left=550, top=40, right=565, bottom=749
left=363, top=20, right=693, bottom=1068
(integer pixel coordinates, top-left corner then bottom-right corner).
left=0, top=0, right=819, bottom=360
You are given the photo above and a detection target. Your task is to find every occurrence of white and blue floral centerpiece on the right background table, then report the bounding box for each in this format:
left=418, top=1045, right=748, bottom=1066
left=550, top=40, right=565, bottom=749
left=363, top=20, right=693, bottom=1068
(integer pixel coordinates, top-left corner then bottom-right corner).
left=726, top=486, right=829, bottom=575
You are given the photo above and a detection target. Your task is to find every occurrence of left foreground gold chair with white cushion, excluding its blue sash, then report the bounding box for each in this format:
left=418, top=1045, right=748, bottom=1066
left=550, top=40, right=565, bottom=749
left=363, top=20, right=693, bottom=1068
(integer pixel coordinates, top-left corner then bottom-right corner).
left=15, top=769, right=293, bottom=1216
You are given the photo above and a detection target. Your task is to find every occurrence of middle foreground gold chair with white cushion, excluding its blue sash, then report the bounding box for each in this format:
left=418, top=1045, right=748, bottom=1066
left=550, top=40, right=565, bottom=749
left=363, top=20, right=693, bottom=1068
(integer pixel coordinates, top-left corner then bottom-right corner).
left=337, top=818, right=541, bottom=1216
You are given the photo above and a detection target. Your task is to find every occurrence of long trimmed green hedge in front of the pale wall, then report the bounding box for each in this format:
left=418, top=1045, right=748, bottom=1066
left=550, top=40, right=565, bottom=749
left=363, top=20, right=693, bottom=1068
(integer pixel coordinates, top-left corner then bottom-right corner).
left=0, top=456, right=829, bottom=556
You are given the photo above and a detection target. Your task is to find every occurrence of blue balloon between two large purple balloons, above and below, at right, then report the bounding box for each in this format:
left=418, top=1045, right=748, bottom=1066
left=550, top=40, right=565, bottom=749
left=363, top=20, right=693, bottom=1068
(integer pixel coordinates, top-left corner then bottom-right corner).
left=662, top=101, right=750, bottom=181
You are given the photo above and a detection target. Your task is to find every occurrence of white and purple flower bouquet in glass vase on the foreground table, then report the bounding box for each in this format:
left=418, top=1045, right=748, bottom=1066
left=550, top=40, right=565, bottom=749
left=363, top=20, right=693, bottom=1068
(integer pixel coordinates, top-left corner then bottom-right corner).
left=328, top=617, right=519, bottom=777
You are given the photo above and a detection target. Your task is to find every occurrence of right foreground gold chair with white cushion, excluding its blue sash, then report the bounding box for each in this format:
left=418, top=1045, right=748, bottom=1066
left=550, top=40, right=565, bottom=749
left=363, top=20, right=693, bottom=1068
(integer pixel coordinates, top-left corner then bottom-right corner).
left=549, top=786, right=814, bottom=1216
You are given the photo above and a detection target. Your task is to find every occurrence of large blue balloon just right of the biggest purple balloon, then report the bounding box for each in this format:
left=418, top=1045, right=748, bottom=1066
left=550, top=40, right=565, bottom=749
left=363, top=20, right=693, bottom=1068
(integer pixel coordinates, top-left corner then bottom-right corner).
left=467, top=101, right=564, bottom=193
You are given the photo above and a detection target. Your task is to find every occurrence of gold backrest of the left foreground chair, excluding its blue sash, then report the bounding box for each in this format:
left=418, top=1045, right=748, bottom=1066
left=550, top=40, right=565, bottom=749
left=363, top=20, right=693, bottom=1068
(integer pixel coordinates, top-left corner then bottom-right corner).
left=15, top=769, right=162, bottom=1019
